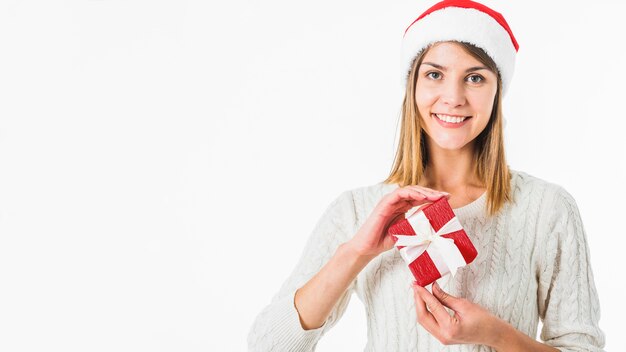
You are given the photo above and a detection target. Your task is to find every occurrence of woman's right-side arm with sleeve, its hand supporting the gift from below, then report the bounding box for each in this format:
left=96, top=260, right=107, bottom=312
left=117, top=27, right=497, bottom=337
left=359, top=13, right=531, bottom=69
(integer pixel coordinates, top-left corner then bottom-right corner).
left=413, top=188, right=604, bottom=352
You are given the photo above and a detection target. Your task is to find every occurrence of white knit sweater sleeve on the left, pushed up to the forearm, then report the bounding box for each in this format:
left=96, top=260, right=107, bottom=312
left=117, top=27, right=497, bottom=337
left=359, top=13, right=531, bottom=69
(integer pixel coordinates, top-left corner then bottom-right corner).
left=248, top=191, right=356, bottom=351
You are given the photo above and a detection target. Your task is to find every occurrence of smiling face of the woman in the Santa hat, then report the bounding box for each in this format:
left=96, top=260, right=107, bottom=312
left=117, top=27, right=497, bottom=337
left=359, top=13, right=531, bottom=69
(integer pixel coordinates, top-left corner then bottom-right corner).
left=415, top=42, right=498, bottom=150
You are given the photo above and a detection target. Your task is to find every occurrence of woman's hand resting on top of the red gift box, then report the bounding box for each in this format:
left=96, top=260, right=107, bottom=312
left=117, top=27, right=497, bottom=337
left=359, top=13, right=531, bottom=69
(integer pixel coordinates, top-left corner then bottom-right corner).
left=346, top=186, right=450, bottom=259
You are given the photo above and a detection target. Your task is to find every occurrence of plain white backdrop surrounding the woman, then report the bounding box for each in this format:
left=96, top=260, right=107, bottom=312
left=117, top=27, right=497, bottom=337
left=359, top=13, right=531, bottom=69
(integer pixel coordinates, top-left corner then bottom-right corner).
left=0, top=0, right=626, bottom=352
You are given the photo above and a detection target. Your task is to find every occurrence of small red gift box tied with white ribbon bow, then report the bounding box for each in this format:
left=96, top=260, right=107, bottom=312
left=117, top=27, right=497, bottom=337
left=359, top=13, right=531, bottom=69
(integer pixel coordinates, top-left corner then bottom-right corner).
left=387, top=197, right=478, bottom=287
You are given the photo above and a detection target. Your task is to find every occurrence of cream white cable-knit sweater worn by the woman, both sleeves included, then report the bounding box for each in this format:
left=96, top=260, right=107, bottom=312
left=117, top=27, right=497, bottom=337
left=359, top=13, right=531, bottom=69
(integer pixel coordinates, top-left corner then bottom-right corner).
left=248, top=171, right=604, bottom=351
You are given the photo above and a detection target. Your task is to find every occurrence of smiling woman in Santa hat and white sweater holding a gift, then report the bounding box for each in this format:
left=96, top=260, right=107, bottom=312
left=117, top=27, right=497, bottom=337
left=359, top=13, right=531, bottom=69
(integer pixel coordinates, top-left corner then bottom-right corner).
left=248, top=1, right=604, bottom=351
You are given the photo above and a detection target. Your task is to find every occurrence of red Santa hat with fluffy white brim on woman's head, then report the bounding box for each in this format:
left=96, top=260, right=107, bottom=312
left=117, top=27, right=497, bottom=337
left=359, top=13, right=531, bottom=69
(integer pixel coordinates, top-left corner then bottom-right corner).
left=402, top=0, right=519, bottom=94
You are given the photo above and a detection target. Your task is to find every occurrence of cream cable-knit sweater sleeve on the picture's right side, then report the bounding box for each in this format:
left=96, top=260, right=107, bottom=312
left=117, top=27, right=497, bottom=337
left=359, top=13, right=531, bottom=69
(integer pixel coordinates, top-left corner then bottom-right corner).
left=538, top=187, right=605, bottom=351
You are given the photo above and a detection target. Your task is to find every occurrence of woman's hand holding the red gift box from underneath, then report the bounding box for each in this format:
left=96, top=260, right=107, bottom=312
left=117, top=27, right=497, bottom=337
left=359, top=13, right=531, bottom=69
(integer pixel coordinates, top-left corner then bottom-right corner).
left=413, top=282, right=503, bottom=347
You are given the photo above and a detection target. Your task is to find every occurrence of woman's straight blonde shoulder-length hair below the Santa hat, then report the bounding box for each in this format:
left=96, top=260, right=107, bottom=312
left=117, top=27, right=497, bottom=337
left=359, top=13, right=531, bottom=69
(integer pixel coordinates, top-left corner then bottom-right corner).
left=383, top=42, right=511, bottom=215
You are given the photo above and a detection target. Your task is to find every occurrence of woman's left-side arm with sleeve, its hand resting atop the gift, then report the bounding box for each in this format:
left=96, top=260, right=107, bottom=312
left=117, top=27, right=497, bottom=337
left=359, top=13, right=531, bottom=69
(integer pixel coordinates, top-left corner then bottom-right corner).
left=248, top=186, right=443, bottom=351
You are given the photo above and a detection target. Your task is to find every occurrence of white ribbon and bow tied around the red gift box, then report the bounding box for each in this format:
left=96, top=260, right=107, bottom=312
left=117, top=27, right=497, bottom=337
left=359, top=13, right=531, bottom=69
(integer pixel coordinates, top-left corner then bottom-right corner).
left=395, top=211, right=467, bottom=276
